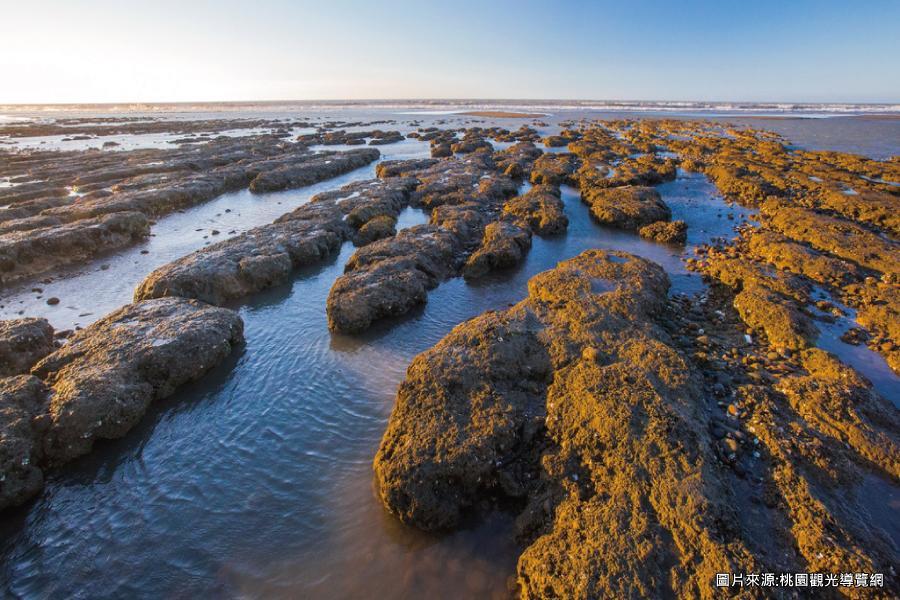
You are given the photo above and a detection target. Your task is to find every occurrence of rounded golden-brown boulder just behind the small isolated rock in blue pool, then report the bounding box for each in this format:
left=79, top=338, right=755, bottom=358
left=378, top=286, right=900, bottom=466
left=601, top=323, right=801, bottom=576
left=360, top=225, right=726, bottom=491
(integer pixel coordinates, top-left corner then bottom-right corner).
left=581, top=185, right=672, bottom=231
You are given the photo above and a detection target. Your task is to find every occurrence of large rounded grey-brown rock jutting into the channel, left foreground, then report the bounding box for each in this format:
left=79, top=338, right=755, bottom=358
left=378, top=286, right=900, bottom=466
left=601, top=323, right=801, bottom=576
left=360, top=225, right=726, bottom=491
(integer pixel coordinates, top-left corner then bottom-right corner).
left=32, top=298, right=243, bottom=464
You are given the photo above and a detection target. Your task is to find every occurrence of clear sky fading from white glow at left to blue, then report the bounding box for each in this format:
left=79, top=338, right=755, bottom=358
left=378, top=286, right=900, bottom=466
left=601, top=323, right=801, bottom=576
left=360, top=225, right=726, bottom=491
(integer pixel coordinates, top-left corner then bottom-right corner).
left=0, top=0, right=900, bottom=104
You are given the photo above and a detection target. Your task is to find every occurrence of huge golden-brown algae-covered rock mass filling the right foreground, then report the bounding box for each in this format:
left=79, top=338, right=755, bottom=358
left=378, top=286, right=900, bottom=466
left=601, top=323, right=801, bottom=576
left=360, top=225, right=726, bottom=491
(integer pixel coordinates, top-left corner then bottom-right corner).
left=374, top=251, right=900, bottom=598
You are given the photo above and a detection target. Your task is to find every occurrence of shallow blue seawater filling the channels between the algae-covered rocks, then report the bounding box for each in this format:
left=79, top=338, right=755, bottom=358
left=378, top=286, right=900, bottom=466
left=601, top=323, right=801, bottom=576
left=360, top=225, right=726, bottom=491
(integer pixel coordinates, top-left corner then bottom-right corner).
left=0, top=107, right=900, bottom=598
